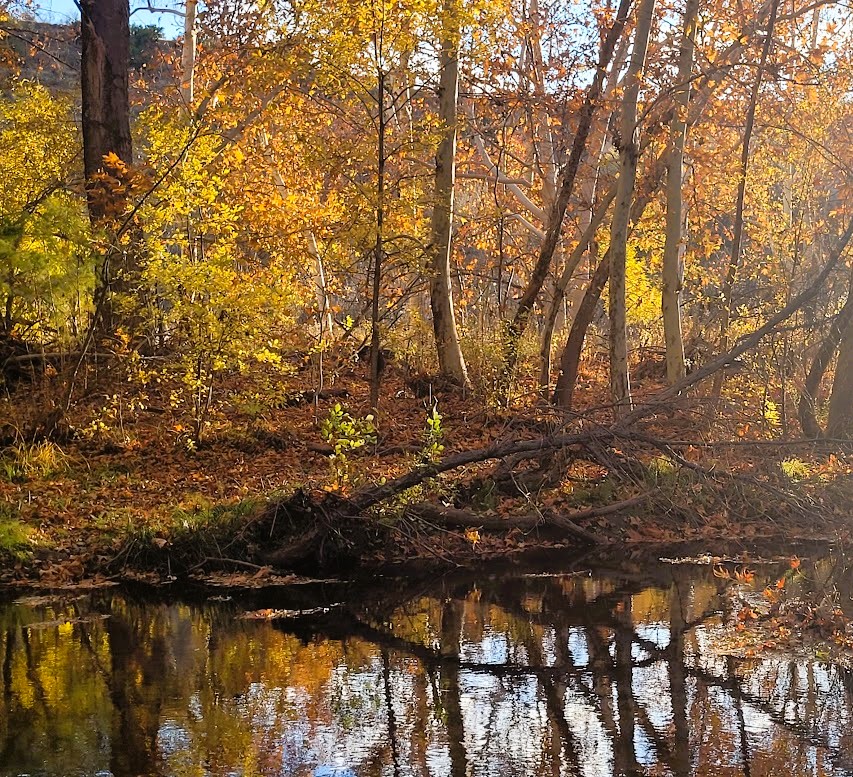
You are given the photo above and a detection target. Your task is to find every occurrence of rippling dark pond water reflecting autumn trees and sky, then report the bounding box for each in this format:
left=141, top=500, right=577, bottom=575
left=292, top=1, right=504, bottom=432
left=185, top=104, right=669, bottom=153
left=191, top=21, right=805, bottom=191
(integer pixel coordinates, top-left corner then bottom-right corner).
left=0, top=548, right=853, bottom=777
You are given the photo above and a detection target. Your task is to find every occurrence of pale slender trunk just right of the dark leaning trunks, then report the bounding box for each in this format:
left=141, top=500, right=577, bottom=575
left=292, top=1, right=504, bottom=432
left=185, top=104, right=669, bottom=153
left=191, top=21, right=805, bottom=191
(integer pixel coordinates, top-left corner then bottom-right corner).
left=608, top=0, right=655, bottom=414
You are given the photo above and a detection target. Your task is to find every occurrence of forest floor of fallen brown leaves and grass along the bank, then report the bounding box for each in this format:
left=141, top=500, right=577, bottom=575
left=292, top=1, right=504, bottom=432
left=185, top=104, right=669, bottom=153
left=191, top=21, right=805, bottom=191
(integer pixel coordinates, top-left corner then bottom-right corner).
left=0, top=358, right=853, bottom=587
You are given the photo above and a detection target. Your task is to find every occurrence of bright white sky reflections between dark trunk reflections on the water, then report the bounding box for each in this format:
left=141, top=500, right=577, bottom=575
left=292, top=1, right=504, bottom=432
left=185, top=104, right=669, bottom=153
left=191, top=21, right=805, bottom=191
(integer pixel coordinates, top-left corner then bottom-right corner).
left=160, top=592, right=850, bottom=777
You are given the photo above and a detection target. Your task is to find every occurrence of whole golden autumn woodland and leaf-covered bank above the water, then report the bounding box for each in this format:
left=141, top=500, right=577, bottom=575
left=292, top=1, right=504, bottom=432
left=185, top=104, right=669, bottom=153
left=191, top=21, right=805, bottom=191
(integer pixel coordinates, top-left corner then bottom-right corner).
left=0, top=0, right=853, bottom=582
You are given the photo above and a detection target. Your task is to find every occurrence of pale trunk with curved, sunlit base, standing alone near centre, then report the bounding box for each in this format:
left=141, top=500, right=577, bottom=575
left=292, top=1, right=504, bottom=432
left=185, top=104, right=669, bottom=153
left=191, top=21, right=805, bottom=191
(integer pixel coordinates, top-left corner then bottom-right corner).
left=429, top=0, right=469, bottom=386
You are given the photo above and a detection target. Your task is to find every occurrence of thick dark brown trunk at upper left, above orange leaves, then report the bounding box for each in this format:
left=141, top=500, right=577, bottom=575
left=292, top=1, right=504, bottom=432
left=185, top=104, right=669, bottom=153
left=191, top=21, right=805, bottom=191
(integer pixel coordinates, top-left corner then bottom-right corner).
left=80, top=0, right=133, bottom=223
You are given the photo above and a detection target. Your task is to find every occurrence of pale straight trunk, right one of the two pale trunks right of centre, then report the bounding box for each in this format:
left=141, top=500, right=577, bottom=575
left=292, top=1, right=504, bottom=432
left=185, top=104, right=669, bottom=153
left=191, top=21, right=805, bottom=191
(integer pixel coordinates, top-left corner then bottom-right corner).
left=661, top=0, right=699, bottom=384
